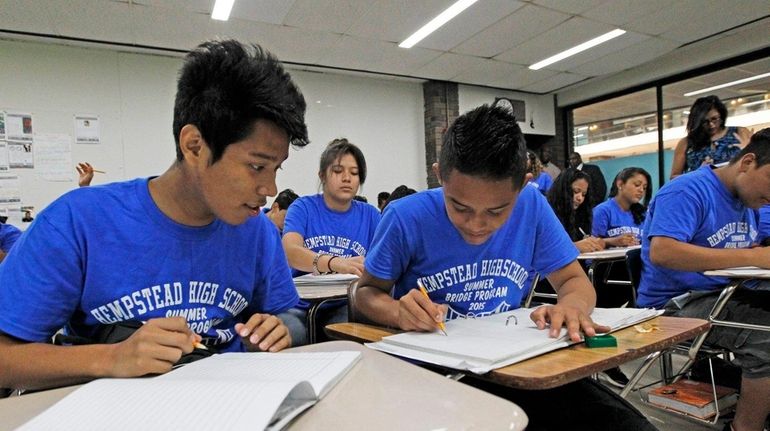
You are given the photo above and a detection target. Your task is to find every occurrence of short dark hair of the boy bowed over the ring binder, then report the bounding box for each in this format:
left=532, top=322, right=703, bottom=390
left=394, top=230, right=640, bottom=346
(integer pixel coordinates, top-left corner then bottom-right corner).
left=439, top=105, right=527, bottom=189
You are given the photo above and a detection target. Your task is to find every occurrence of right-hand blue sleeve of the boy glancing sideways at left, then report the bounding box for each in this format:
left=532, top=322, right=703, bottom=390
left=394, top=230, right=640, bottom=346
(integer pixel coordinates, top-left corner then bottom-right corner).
left=247, top=221, right=299, bottom=317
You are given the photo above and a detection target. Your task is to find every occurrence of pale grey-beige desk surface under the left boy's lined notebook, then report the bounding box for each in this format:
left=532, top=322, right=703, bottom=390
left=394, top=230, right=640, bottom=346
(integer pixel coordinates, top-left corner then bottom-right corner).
left=0, top=341, right=527, bottom=431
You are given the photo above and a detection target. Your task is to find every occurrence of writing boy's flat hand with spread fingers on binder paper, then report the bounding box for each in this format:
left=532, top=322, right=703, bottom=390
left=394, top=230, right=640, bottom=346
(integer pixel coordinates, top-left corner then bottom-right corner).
left=529, top=304, right=610, bottom=342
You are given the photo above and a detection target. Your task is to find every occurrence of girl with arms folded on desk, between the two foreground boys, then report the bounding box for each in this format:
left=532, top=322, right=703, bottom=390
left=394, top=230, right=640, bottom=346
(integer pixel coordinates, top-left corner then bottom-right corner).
left=281, top=139, right=380, bottom=346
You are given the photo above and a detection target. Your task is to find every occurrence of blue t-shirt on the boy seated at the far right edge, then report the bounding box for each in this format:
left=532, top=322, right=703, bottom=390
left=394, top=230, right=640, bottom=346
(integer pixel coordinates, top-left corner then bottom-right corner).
left=636, top=166, right=757, bottom=308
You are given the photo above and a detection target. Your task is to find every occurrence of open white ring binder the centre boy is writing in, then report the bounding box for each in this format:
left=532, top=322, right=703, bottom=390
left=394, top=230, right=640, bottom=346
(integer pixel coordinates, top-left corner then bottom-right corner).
left=367, top=308, right=662, bottom=374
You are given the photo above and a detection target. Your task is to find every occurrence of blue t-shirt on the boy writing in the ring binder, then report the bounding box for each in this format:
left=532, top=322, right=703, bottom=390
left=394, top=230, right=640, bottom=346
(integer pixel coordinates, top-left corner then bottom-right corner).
left=365, top=187, right=578, bottom=319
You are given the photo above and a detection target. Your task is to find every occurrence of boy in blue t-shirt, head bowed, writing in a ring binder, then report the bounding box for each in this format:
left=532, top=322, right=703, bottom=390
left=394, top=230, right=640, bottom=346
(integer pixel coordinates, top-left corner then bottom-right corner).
left=357, top=105, right=653, bottom=430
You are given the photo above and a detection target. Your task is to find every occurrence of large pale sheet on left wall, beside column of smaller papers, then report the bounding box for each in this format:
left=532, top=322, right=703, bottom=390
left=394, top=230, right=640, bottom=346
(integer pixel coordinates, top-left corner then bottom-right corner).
left=34, top=133, right=72, bottom=182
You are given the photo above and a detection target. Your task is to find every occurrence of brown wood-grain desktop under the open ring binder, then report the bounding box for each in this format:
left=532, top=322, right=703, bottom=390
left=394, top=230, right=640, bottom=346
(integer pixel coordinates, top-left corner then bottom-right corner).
left=326, top=316, right=709, bottom=389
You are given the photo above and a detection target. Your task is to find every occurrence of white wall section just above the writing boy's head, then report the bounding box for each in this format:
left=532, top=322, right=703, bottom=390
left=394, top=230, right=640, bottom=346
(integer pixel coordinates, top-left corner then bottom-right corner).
left=458, top=85, right=556, bottom=136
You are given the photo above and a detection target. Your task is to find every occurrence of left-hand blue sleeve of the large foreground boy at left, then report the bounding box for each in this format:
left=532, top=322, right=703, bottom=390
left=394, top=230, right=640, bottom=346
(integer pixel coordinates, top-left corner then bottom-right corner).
left=0, top=209, right=86, bottom=342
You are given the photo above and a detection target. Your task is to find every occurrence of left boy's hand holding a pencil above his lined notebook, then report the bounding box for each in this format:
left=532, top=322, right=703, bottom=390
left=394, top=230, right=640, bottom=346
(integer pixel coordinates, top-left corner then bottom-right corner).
left=108, top=317, right=201, bottom=377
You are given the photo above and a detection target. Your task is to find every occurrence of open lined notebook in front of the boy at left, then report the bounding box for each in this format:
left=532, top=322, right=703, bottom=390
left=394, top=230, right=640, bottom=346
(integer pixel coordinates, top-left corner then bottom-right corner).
left=19, top=352, right=361, bottom=431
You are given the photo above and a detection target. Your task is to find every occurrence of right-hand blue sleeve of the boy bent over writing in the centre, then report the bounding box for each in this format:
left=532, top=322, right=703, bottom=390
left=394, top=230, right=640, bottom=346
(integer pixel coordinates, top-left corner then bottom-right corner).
left=532, top=193, right=578, bottom=277
